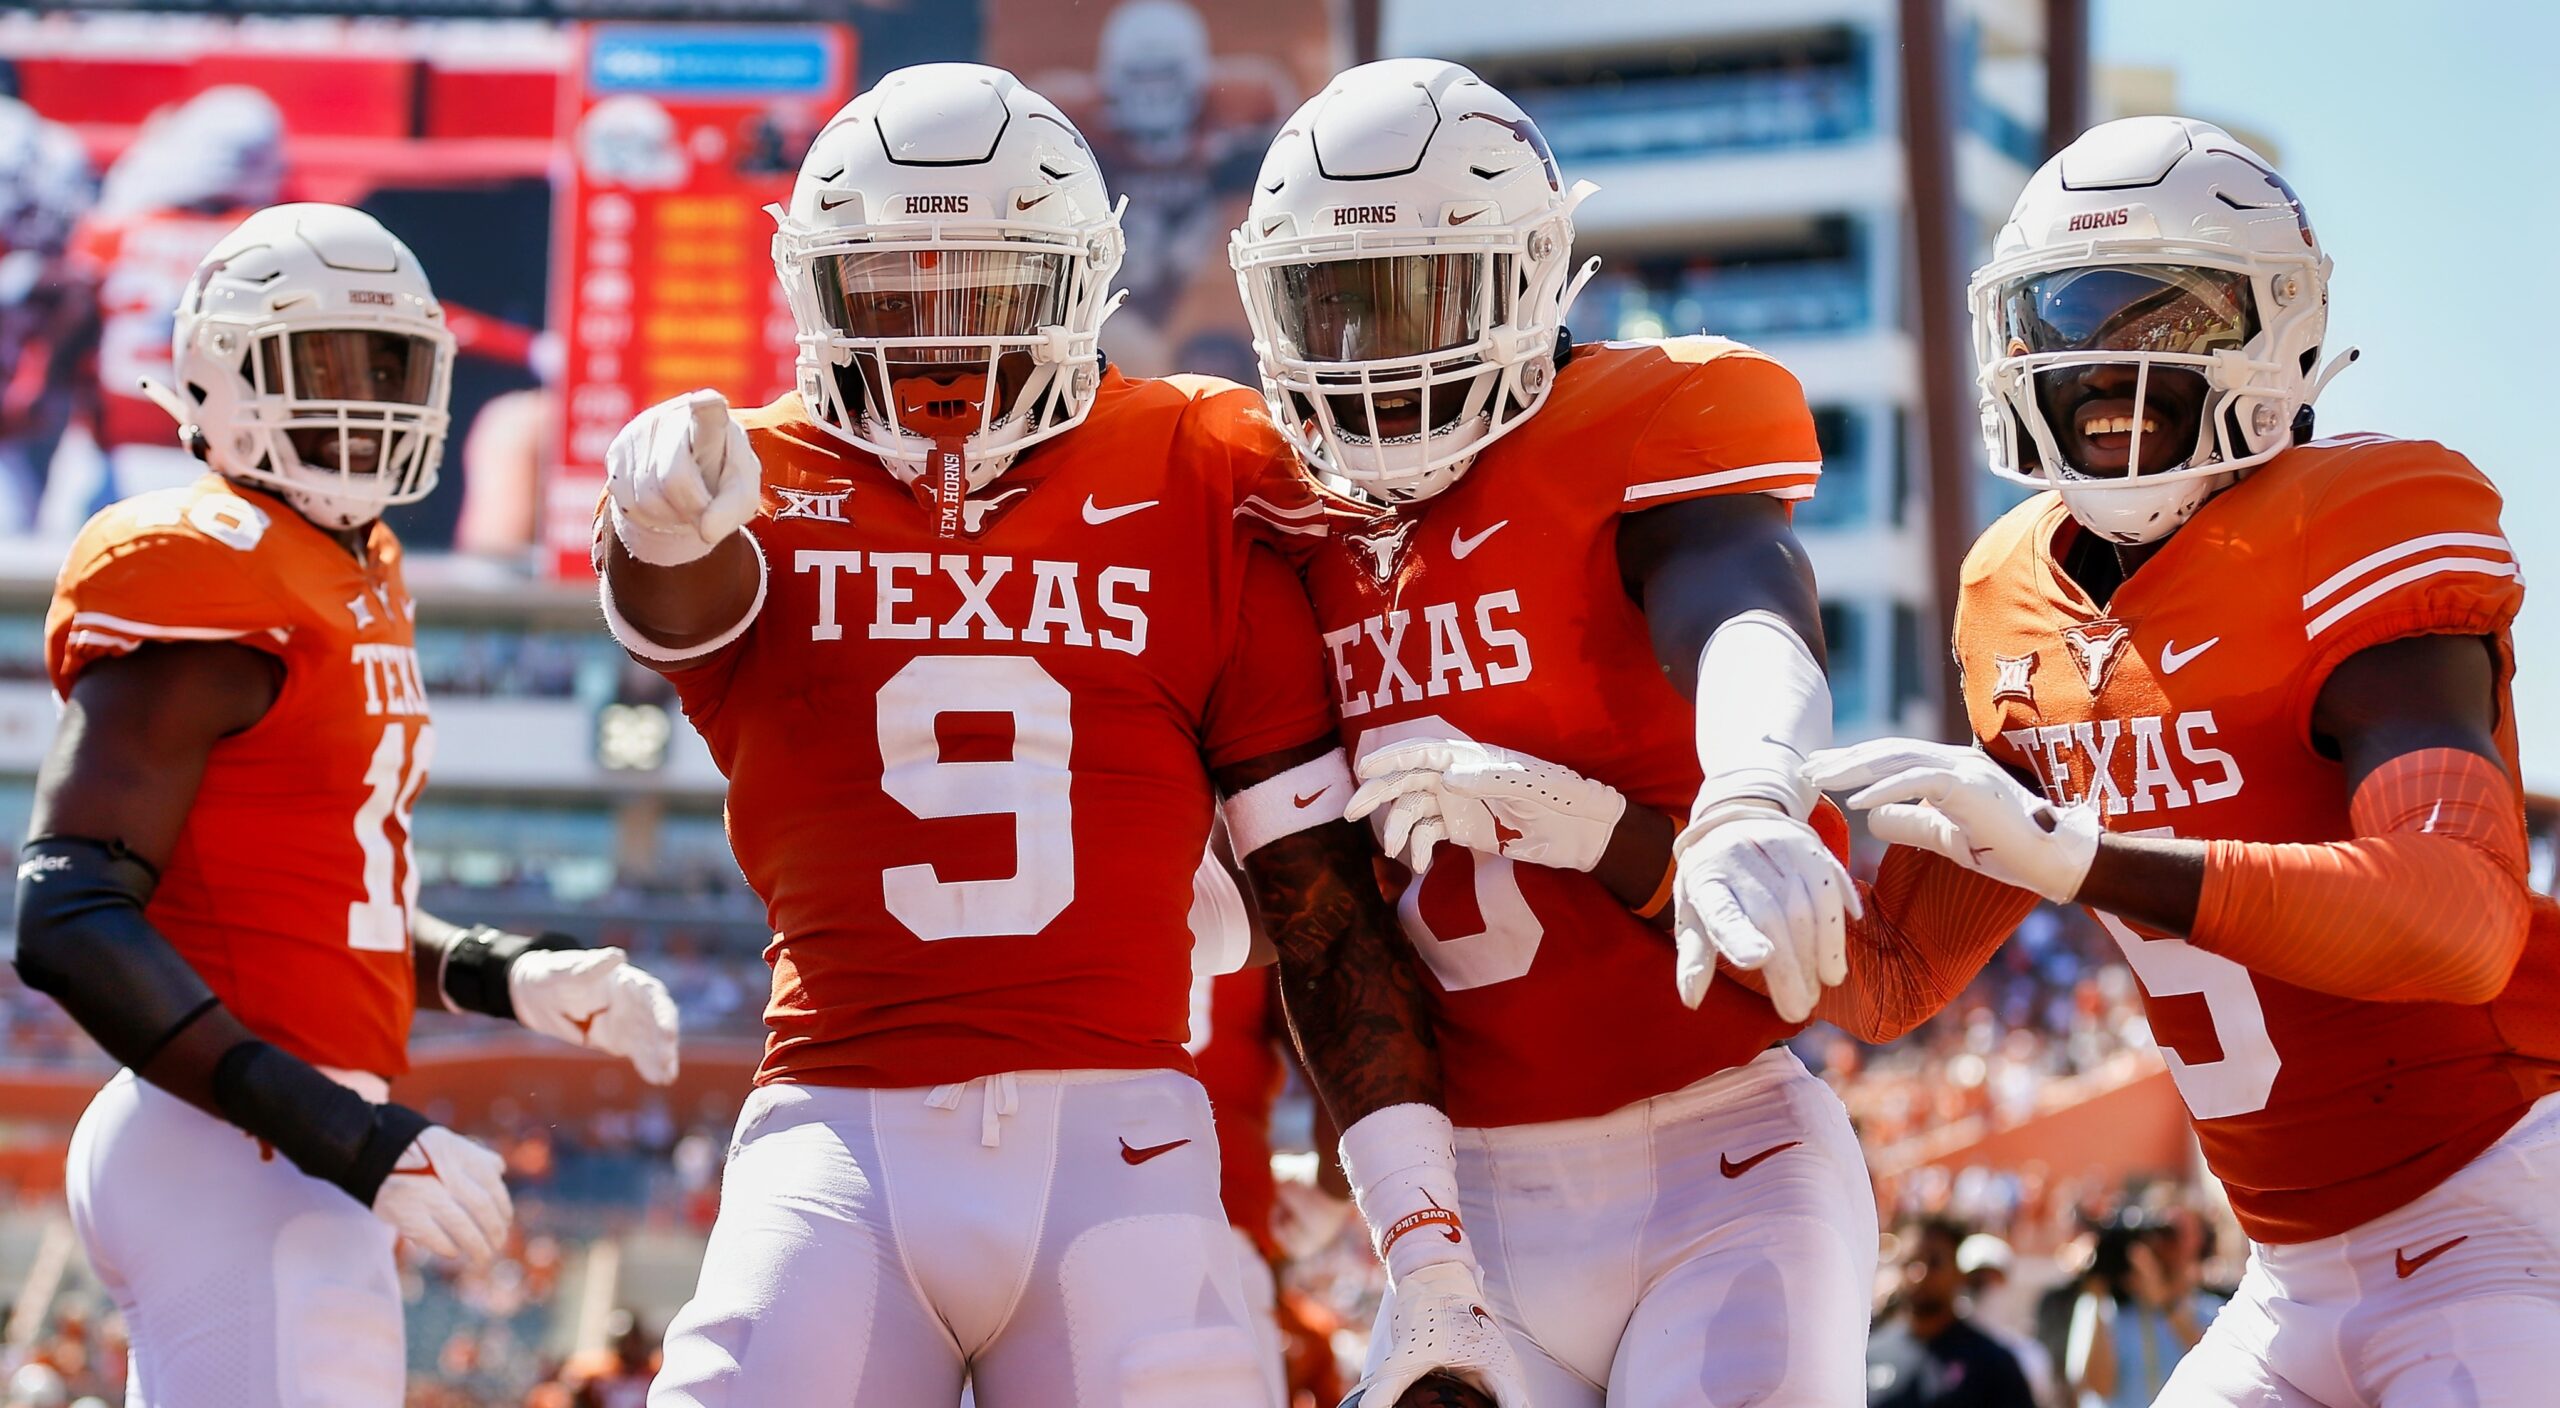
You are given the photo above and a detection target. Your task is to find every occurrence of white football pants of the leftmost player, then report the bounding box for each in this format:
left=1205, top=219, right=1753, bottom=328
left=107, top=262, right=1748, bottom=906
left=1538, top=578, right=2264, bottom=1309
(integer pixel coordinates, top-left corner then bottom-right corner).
left=67, top=1070, right=407, bottom=1408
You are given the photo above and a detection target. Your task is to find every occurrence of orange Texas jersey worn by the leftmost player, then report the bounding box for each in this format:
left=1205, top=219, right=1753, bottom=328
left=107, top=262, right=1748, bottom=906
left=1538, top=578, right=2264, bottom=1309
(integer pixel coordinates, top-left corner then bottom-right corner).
left=44, top=474, right=435, bottom=1078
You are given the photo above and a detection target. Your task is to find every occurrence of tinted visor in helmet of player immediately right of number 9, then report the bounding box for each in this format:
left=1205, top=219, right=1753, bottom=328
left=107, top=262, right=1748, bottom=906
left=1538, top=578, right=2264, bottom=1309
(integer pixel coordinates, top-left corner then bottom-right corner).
left=1270, top=253, right=1500, bottom=361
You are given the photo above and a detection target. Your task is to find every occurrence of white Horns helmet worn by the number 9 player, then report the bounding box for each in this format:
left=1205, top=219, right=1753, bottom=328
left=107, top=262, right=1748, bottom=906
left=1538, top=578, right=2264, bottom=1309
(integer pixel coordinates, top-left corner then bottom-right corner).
left=768, top=64, right=1121, bottom=494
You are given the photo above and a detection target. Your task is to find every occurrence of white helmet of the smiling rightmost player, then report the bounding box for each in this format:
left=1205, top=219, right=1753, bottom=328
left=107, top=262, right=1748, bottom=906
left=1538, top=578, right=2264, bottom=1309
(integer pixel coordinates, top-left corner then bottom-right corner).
left=1969, top=118, right=2355, bottom=543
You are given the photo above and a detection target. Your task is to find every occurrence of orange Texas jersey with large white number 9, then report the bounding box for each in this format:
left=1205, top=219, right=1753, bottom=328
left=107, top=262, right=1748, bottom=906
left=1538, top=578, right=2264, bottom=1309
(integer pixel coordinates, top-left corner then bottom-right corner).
left=650, top=374, right=1331, bottom=1085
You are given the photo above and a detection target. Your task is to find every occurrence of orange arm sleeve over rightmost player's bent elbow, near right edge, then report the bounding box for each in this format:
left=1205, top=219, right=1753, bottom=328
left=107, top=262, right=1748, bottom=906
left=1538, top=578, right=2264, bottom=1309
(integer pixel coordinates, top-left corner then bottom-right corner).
left=2189, top=748, right=2529, bottom=1004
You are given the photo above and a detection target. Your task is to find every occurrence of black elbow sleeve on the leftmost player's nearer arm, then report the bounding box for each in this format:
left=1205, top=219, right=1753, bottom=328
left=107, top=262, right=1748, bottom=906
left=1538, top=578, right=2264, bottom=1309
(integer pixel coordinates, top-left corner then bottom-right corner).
left=18, top=837, right=215, bottom=1070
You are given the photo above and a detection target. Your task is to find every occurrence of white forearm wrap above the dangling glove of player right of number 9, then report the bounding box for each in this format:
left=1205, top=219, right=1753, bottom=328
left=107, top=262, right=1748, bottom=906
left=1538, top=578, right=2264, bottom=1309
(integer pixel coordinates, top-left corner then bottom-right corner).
left=1690, top=612, right=1830, bottom=822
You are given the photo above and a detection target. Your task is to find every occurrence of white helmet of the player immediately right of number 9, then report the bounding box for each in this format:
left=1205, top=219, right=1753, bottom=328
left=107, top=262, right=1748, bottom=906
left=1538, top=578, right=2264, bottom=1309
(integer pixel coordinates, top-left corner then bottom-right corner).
left=1229, top=59, right=1600, bottom=502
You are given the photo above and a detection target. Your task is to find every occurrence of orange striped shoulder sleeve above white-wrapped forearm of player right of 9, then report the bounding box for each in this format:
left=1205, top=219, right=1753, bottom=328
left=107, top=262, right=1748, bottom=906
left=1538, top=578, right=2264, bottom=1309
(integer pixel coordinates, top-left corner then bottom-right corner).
left=1626, top=338, right=1823, bottom=512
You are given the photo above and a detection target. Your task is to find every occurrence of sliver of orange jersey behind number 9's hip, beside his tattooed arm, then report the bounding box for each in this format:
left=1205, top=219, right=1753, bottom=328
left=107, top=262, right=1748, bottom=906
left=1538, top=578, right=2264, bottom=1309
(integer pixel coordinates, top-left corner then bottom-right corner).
left=1190, top=968, right=1288, bottom=1257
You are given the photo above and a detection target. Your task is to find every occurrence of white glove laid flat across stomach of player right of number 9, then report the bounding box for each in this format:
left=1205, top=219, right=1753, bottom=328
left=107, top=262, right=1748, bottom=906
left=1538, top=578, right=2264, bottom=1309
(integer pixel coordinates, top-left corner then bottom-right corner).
left=1341, top=737, right=1626, bottom=876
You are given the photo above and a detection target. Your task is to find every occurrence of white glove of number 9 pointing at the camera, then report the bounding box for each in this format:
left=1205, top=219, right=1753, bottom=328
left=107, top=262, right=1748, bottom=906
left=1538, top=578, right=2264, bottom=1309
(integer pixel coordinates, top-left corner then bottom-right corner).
left=604, top=392, right=763, bottom=566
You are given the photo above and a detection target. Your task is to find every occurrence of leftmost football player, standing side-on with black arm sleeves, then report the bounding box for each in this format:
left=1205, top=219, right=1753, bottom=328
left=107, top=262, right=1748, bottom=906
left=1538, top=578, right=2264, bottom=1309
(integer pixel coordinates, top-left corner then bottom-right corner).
left=18, top=205, right=676, bottom=1408
